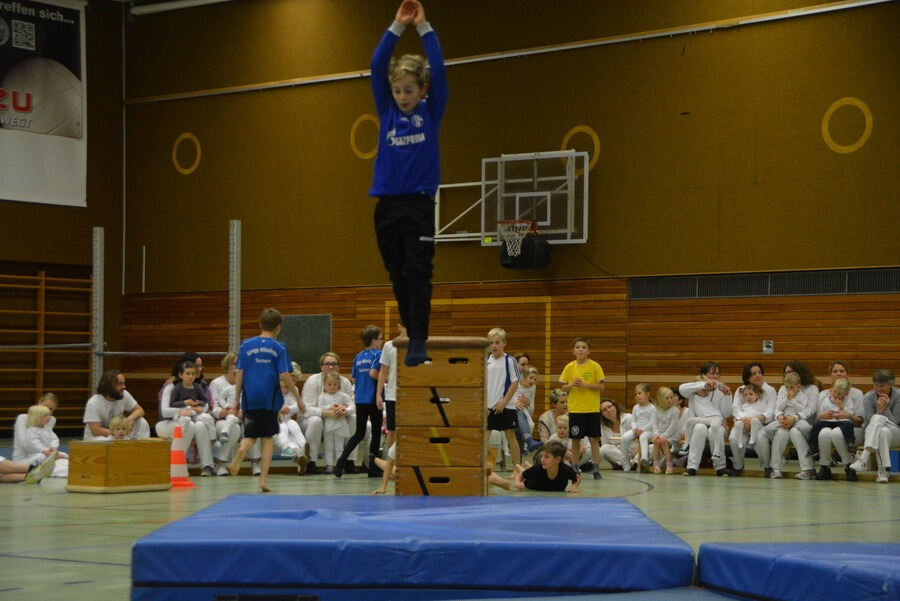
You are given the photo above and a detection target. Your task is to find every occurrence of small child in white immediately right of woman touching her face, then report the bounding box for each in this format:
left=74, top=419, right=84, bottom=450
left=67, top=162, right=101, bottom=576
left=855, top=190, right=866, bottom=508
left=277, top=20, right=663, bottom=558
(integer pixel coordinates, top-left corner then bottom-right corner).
left=728, top=382, right=775, bottom=475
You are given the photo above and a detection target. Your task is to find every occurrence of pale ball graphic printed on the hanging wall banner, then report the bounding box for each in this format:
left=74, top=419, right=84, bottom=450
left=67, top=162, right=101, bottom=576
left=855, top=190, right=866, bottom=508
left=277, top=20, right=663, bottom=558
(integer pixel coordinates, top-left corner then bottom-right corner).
left=0, top=58, right=82, bottom=138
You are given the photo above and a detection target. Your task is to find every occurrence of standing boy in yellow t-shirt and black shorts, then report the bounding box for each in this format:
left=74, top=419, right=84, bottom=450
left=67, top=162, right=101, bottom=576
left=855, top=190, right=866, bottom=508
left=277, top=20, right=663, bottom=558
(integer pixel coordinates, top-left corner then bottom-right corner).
left=559, top=338, right=606, bottom=480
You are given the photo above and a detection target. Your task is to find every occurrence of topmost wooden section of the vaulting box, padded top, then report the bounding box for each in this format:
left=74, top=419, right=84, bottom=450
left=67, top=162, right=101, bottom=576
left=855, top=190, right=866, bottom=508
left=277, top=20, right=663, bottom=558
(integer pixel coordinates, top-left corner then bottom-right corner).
left=394, top=336, right=488, bottom=390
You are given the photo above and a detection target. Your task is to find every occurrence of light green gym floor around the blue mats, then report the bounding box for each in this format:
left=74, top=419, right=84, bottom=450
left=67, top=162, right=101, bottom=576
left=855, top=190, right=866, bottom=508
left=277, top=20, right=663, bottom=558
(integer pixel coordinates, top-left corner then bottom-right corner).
left=0, top=463, right=900, bottom=601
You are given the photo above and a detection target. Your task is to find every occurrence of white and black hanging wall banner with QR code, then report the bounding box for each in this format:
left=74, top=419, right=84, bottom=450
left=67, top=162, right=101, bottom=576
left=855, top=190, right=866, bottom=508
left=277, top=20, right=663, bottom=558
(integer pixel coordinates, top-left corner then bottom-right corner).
left=0, top=0, right=87, bottom=207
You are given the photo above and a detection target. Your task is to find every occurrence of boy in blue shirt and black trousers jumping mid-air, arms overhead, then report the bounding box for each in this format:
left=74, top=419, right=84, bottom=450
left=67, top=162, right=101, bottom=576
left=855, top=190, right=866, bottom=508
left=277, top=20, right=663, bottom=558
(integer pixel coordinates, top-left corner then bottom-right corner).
left=369, top=0, right=447, bottom=366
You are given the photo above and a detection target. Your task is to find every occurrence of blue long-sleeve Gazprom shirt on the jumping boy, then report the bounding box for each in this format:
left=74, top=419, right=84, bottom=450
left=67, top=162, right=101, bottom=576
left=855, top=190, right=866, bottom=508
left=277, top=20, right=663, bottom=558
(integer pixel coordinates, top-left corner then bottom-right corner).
left=369, top=22, right=448, bottom=197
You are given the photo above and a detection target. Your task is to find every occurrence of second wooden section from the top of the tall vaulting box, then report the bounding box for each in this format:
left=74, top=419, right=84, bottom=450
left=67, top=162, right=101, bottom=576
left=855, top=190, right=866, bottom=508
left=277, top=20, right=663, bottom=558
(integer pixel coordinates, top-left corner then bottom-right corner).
left=397, top=386, right=487, bottom=428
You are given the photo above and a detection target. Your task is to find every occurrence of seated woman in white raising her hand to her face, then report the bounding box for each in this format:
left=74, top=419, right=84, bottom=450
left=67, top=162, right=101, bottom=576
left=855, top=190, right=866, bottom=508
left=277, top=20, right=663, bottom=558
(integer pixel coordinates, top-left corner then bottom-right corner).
left=678, top=361, right=732, bottom=476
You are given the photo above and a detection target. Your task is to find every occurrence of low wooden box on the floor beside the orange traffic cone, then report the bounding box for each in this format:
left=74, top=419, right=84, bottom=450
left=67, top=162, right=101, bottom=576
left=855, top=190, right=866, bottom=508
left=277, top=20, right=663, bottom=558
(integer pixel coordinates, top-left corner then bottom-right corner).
left=66, top=438, right=172, bottom=493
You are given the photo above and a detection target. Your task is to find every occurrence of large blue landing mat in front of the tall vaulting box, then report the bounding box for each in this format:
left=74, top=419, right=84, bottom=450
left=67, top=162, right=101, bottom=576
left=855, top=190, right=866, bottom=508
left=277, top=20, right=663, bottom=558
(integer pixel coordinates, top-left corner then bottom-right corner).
left=131, top=495, right=694, bottom=601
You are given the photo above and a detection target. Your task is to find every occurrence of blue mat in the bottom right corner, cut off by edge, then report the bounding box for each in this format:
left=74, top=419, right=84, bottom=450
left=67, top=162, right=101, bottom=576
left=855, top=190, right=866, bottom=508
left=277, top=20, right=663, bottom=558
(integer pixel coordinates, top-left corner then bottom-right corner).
left=697, top=543, right=900, bottom=601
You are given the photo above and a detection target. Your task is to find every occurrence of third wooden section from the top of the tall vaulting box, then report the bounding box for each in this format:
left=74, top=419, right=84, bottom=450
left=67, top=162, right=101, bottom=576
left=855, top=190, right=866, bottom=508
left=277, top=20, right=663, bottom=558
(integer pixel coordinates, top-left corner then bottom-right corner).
left=397, top=428, right=485, bottom=467
